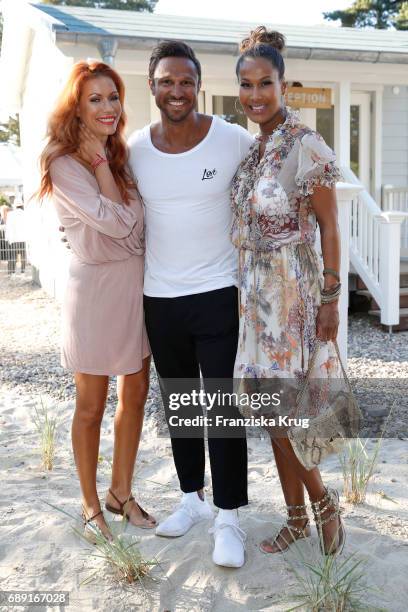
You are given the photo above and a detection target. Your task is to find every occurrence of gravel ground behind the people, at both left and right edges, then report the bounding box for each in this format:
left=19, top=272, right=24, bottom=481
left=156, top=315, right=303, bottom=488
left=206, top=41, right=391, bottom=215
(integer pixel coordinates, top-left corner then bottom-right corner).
left=0, top=262, right=408, bottom=437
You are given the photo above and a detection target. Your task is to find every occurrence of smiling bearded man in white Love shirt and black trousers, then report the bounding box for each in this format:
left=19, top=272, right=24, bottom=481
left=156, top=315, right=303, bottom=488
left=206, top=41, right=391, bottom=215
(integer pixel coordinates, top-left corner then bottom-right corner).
left=129, top=41, right=252, bottom=567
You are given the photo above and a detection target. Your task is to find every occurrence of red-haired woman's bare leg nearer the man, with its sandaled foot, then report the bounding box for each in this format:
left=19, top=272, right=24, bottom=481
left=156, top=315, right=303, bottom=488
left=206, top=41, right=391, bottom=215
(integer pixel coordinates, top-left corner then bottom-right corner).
left=106, top=357, right=155, bottom=526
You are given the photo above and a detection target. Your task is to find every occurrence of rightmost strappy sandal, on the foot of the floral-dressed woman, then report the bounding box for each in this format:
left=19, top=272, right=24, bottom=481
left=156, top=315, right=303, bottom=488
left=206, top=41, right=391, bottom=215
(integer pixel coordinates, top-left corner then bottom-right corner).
left=310, top=487, right=346, bottom=555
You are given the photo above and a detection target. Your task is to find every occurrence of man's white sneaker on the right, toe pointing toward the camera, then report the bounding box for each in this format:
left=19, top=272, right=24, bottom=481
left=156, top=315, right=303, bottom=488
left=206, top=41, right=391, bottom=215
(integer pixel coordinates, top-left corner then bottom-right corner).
left=209, top=517, right=246, bottom=567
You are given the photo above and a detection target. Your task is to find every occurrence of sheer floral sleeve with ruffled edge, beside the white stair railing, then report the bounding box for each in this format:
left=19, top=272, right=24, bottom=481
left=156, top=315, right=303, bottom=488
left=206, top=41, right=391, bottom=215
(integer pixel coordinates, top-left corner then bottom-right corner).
left=295, top=132, right=341, bottom=196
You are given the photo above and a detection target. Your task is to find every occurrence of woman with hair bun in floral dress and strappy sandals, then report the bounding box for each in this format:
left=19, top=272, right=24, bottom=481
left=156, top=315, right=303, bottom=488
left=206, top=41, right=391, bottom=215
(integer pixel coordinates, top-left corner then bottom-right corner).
left=232, top=26, right=345, bottom=554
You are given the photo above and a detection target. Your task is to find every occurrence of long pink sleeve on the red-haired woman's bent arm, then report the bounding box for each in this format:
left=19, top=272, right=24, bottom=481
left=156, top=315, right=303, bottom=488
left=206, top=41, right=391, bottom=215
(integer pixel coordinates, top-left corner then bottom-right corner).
left=50, top=157, right=137, bottom=238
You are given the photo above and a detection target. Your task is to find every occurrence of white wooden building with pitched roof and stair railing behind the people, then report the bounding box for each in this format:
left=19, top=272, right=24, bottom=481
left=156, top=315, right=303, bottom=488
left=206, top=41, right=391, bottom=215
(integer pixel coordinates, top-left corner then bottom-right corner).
left=0, top=0, right=408, bottom=352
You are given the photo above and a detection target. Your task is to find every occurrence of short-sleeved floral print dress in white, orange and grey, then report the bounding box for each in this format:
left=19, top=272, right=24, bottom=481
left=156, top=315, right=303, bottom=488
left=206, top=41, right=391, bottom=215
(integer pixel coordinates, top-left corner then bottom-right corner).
left=231, top=109, right=340, bottom=466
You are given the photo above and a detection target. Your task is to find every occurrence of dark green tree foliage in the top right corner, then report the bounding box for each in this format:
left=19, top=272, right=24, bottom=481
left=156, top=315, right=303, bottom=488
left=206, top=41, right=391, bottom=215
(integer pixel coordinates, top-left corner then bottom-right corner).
left=323, top=0, right=408, bottom=30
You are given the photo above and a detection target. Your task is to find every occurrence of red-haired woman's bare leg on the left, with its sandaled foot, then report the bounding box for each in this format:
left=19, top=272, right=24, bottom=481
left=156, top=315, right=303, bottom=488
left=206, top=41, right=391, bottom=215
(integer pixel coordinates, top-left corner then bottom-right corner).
left=72, top=372, right=110, bottom=535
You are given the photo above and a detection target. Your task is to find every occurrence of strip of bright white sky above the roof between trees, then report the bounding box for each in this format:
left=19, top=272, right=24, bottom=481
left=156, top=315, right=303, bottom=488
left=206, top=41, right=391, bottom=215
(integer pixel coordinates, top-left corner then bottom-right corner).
left=155, top=0, right=353, bottom=25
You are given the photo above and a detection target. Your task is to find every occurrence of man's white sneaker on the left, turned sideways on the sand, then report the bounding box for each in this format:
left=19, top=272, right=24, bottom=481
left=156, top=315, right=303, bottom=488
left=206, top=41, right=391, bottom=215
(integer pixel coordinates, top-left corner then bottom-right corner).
left=156, top=492, right=214, bottom=538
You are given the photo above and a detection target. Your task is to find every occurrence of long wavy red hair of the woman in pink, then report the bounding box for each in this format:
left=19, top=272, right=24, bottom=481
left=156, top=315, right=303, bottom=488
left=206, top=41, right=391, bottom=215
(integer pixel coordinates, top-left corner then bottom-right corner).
left=37, top=61, right=136, bottom=204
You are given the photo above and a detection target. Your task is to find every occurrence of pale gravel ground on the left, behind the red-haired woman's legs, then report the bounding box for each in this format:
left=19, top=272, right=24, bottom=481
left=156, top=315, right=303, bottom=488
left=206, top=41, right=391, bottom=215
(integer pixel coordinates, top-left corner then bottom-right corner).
left=0, top=262, right=160, bottom=414
